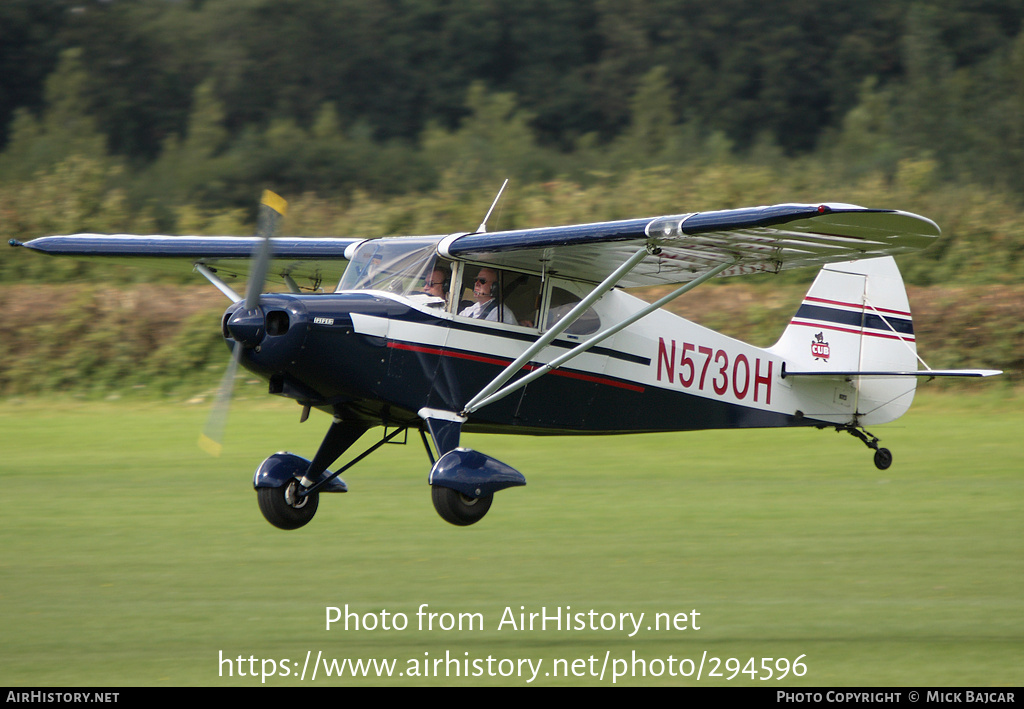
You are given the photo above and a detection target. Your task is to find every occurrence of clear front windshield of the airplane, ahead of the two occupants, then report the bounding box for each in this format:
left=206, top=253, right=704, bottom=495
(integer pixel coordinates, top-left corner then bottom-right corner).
left=338, top=237, right=440, bottom=295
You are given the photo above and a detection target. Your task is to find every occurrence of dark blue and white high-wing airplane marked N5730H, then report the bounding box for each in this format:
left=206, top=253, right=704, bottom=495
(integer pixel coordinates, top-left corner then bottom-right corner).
left=11, top=188, right=999, bottom=529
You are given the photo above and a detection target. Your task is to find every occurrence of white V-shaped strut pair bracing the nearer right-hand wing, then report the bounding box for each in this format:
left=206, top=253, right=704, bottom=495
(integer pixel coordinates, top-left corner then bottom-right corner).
left=462, top=255, right=740, bottom=416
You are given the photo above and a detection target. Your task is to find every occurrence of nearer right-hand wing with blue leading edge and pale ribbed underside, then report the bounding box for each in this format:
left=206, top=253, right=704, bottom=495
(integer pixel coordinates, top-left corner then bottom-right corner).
left=438, top=204, right=940, bottom=288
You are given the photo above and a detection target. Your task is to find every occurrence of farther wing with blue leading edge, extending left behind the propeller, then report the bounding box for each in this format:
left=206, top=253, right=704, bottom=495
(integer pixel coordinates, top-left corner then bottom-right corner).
left=11, top=234, right=361, bottom=288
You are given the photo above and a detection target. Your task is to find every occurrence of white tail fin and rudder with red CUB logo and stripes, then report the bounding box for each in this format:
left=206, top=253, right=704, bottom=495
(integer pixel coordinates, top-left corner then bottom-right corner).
left=771, top=257, right=918, bottom=425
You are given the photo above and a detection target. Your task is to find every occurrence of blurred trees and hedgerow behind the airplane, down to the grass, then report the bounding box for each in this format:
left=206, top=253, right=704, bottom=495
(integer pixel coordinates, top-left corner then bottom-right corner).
left=0, top=0, right=1024, bottom=393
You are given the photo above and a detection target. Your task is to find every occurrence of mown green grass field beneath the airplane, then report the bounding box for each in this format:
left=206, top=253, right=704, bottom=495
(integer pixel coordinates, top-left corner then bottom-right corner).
left=0, top=392, right=1024, bottom=687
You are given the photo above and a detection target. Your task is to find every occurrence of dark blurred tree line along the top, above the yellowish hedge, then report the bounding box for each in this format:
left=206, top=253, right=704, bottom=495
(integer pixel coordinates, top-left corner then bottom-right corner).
left=0, top=0, right=1024, bottom=206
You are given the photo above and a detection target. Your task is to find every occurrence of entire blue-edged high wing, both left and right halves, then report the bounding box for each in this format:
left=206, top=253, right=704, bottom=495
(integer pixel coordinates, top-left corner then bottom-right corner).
left=11, top=204, right=939, bottom=288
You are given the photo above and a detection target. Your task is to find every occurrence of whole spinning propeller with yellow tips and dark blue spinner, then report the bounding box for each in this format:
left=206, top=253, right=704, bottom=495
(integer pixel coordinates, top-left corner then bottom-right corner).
left=199, top=190, right=288, bottom=456
